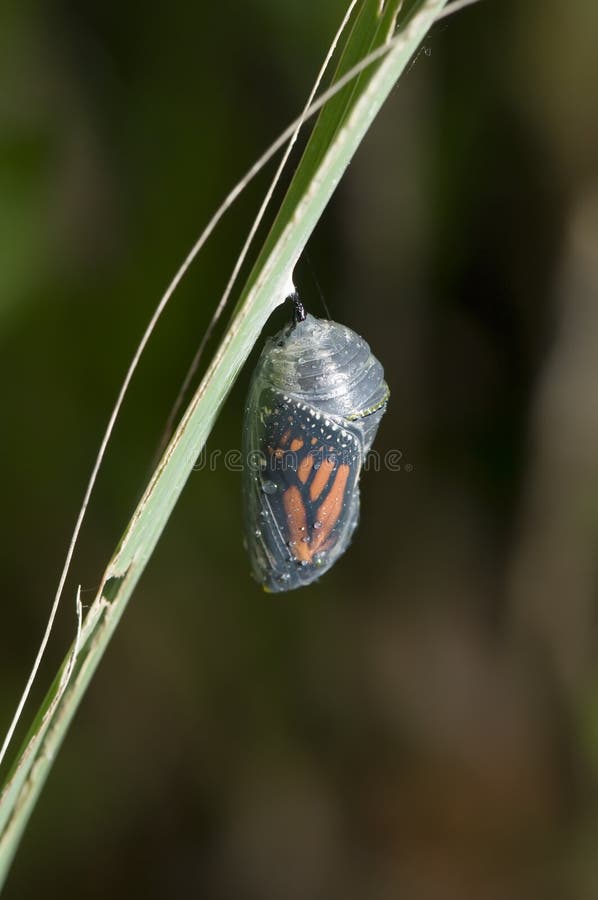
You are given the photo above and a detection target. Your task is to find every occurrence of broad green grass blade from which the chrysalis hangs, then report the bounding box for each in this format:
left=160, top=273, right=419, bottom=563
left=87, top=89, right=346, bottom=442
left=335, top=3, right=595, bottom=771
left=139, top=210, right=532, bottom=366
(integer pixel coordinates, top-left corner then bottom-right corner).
left=0, top=0, right=446, bottom=886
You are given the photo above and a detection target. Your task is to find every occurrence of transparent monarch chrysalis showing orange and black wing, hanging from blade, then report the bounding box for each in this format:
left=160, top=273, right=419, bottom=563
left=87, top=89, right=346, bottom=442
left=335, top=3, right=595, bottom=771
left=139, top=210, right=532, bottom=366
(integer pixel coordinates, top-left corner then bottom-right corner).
left=243, top=295, right=389, bottom=591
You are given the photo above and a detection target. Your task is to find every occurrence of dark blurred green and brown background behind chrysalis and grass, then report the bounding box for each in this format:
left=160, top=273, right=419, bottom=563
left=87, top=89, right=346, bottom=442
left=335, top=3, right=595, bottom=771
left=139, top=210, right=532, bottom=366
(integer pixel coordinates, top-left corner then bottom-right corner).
left=0, top=0, right=598, bottom=900
